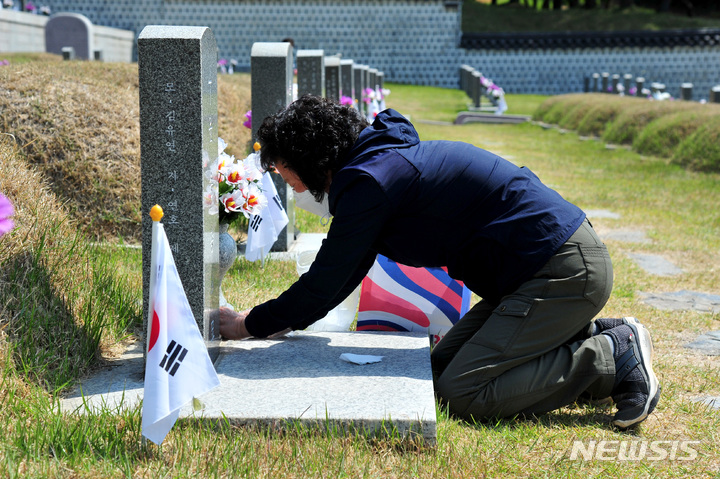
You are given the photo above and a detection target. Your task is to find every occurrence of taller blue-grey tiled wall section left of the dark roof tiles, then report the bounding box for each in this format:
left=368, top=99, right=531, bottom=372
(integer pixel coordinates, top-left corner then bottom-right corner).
left=35, top=0, right=461, bottom=86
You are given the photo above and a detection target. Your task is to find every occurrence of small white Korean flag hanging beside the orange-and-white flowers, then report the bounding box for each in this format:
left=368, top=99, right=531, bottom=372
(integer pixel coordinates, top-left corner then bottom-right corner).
left=245, top=171, right=288, bottom=261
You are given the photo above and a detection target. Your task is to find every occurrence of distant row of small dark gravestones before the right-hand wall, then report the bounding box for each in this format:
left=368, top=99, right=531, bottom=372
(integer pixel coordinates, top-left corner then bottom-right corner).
left=583, top=72, right=720, bottom=103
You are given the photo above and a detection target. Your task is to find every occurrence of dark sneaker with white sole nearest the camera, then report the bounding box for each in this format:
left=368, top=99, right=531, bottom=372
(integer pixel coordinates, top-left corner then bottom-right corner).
left=603, top=324, right=661, bottom=429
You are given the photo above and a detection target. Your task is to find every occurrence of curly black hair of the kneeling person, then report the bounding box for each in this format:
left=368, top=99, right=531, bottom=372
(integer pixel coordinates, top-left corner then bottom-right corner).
left=258, top=95, right=369, bottom=201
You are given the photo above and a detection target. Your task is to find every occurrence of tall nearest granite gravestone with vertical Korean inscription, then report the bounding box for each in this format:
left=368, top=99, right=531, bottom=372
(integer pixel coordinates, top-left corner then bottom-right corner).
left=138, top=26, right=220, bottom=360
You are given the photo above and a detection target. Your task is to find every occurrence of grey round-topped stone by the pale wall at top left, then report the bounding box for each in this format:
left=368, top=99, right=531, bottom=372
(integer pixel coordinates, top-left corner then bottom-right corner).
left=45, top=13, right=94, bottom=60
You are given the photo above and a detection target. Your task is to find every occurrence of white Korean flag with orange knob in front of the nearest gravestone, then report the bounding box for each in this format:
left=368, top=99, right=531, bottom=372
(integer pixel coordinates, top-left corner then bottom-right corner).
left=142, top=205, right=220, bottom=444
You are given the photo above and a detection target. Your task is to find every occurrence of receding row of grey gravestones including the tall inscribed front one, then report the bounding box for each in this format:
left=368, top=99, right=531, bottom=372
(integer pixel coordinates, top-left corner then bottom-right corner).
left=138, top=26, right=383, bottom=359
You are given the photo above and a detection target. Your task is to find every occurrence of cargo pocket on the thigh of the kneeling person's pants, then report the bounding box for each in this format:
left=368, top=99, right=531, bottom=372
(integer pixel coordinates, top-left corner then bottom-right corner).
left=469, top=298, right=533, bottom=353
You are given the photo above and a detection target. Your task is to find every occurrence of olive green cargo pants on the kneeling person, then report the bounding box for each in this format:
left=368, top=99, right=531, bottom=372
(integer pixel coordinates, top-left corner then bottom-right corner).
left=431, top=220, right=615, bottom=420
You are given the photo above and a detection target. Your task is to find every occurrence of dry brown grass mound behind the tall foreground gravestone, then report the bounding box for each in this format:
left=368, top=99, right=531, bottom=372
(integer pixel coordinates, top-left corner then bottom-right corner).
left=0, top=56, right=250, bottom=243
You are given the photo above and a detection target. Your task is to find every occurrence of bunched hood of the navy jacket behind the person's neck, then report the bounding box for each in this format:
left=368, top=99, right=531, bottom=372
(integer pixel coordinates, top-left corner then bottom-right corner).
left=348, top=109, right=420, bottom=163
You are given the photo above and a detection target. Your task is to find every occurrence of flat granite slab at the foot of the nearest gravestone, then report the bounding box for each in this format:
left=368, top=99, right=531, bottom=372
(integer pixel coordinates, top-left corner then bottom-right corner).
left=62, top=332, right=436, bottom=443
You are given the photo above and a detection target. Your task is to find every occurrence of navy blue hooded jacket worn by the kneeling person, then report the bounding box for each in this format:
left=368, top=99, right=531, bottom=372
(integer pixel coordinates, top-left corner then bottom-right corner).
left=245, top=110, right=585, bottom=337
